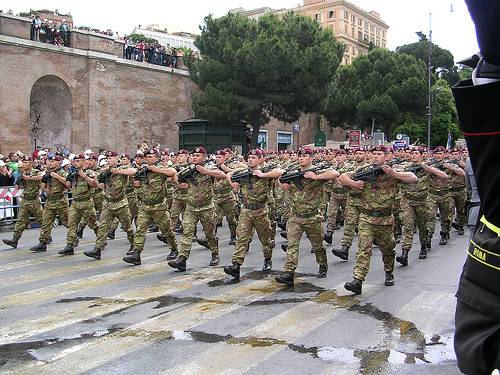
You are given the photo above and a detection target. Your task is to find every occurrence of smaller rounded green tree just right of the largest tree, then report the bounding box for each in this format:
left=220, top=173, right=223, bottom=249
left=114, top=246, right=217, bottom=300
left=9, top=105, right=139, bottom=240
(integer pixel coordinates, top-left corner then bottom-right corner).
left=322, top=48, right=427, bottom=136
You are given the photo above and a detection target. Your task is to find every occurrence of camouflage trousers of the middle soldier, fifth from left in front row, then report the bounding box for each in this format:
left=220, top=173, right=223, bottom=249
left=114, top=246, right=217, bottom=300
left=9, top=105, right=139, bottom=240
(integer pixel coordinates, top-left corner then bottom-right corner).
left=134, top=203, right=177, bottom=252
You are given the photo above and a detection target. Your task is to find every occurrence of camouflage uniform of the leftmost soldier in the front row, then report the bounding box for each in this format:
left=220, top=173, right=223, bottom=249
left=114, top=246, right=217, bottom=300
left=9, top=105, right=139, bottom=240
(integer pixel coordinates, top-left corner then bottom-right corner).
left=14, top=168, right=42, bottom=241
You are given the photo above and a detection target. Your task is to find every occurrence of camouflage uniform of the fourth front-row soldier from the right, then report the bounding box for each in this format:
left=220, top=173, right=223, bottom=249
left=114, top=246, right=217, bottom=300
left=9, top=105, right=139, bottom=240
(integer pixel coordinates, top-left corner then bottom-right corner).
left=179, top=173, right=219, bottom=259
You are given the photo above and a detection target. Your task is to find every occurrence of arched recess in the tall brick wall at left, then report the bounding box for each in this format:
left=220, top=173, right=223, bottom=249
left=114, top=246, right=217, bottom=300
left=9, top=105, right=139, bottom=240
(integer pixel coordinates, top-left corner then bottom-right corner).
left=30, top=75, right=73, bottom=147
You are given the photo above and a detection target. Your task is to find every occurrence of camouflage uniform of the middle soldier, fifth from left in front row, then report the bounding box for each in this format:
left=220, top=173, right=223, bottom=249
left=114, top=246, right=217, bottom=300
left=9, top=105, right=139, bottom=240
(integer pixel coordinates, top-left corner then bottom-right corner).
left=134, top=164, right=177, bottom=252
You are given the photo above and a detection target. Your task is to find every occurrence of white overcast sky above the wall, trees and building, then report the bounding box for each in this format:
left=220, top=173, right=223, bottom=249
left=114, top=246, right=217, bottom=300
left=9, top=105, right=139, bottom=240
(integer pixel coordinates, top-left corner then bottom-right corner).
left=0, top=0, right=478, bottom=60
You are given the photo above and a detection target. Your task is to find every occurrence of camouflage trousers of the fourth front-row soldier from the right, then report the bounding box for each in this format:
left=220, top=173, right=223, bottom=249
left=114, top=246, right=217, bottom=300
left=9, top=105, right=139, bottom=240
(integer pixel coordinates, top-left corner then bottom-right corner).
left=179, top=205, right=219, bottom=258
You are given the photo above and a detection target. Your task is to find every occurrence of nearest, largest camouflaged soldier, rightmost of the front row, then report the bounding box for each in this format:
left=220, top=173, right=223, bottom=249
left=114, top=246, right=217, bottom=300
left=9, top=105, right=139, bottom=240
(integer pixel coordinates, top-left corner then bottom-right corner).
left=339, top=146, right=417, bottom=294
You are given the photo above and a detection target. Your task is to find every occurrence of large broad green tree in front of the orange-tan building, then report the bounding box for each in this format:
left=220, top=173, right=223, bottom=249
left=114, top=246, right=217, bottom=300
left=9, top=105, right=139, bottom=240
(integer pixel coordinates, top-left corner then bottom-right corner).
left=186, top=12, right=344, bottom=146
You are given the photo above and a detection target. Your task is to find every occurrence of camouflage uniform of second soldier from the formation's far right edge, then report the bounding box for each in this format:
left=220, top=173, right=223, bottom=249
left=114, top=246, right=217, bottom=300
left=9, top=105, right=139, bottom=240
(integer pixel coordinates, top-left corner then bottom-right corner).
left=427, top=169, right=452, bottom=238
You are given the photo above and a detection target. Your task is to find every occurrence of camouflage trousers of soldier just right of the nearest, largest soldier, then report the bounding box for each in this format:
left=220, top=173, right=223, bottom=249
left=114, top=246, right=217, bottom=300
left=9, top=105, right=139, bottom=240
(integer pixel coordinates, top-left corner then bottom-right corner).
left=401, top=197, right=429, bottom=251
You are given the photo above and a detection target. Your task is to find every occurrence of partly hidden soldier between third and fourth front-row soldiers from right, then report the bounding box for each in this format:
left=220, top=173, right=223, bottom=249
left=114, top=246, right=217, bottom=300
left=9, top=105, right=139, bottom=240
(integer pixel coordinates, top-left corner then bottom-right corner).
left=214, top=150, right=238, bottom=245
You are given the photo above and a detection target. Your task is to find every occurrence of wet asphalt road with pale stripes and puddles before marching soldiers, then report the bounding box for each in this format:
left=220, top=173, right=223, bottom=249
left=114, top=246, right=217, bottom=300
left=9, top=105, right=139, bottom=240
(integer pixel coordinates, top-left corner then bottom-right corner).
left=0, top=224, right=467, bottom=375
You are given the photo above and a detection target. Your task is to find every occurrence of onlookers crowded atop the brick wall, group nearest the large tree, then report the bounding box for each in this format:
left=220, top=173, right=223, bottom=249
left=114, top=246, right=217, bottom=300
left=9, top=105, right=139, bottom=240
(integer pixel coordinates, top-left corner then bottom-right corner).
left=123, top=36, right=182, bottom=68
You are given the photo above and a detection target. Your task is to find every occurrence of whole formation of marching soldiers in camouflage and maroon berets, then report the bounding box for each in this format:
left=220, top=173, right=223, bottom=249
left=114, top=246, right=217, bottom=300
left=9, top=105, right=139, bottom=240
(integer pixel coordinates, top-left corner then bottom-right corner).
left=3, top=146, right=467, bottom=294
